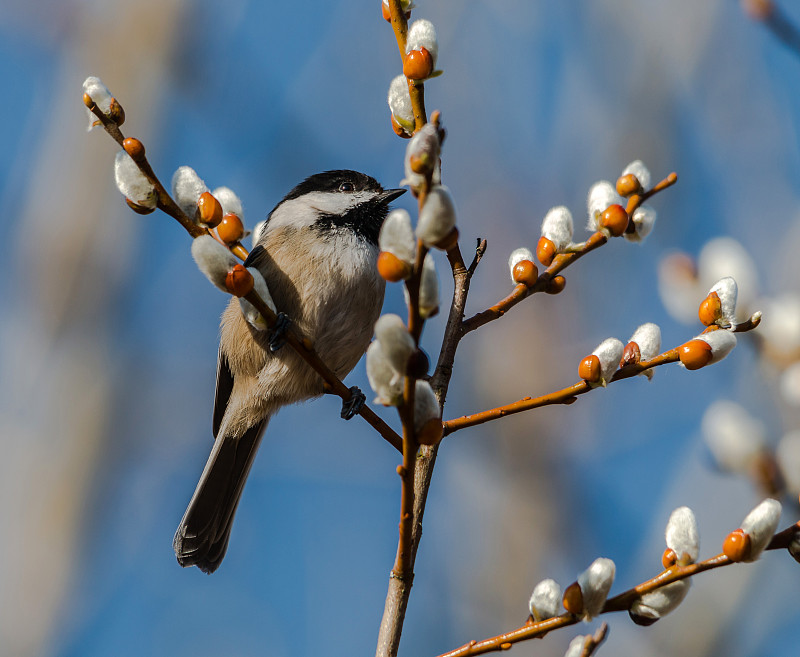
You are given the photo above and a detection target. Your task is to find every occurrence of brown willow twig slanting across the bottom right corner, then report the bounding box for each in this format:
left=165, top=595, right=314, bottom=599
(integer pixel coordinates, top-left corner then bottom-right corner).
left=439, top=522, right=800, bottom=657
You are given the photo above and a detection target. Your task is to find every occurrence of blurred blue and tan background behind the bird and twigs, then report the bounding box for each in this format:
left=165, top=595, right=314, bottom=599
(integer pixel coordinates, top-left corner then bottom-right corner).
left=0, top=0, right=800, bottom=657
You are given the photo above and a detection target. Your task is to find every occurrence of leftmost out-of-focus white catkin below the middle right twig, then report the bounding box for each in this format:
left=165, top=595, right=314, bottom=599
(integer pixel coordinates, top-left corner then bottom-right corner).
left=700, top=399, right=766, bottom=474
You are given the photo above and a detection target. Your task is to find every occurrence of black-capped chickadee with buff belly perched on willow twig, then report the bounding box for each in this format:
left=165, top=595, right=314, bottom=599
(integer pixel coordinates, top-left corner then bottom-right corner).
left=173, top=169, right=406, bottom=573
